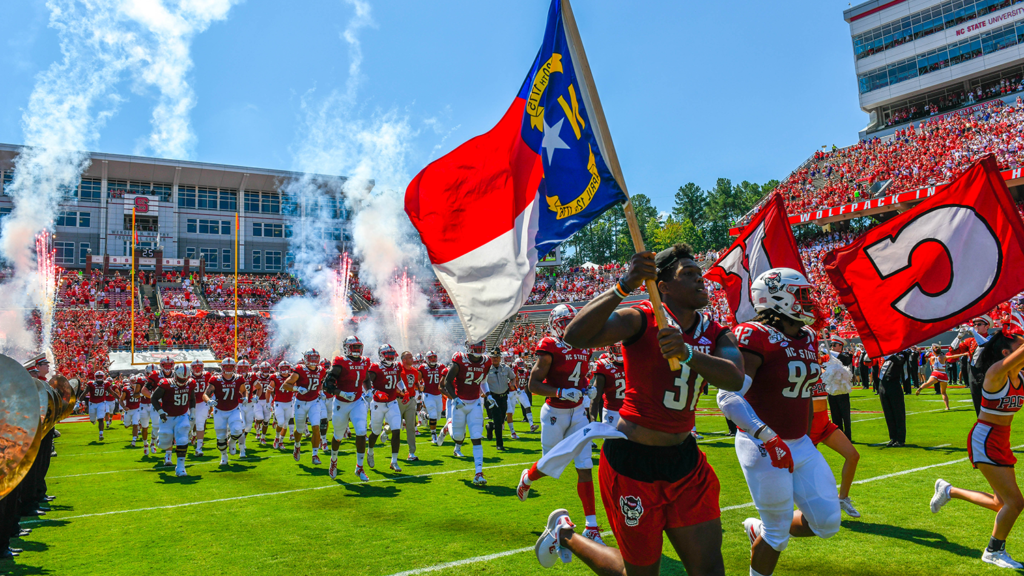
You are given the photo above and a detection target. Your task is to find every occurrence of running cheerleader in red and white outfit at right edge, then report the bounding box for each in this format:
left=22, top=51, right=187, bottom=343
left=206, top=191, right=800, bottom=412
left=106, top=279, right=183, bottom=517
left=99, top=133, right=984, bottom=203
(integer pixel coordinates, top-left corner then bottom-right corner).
left=931, top=325, right=1024, bottom=570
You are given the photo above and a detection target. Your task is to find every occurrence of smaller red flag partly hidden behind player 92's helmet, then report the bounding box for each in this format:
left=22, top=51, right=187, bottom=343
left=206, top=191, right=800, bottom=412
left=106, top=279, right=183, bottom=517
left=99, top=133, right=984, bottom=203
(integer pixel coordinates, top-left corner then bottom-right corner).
left=705, top=194, right=807, bottom=322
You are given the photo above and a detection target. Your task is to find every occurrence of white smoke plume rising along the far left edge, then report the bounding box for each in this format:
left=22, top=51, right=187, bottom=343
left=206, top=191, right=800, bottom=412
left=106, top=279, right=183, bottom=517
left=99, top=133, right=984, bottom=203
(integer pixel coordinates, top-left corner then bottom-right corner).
left=0, top=0, right=230, bottom=357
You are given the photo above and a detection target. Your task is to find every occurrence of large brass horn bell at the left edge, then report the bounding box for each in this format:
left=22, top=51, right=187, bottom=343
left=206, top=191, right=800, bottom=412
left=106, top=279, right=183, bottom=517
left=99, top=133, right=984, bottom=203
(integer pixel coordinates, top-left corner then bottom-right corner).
left=0, top=354, right=79, bottom=498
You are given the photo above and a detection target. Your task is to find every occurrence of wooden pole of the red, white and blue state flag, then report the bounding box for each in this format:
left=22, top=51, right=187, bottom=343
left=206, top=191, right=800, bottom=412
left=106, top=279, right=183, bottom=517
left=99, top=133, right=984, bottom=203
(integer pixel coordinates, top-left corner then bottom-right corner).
left=562, top=0, right=680, bottom=371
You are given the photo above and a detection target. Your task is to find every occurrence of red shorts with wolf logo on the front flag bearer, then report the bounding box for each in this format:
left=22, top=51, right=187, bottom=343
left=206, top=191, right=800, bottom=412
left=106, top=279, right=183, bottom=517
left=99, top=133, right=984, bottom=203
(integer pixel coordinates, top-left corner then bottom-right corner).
left=598, top=441, right=722, bottom=566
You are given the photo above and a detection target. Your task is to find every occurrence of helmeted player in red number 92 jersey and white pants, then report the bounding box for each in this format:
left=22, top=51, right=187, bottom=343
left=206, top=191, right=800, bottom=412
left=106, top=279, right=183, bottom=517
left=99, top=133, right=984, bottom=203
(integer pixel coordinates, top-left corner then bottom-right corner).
left=718, top=269, right=842, bottom=576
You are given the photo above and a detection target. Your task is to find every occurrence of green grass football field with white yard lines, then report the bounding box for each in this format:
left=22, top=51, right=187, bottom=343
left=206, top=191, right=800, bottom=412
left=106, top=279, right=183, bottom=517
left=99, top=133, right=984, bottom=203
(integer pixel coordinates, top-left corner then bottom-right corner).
left=0, top=388, right=1024, bottom=576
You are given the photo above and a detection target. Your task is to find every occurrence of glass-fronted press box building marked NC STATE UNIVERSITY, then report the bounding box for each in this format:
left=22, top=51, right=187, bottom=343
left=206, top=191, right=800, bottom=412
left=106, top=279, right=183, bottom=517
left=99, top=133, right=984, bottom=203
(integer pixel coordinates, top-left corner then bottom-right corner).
left=843, top=0, right=1024, bottom=138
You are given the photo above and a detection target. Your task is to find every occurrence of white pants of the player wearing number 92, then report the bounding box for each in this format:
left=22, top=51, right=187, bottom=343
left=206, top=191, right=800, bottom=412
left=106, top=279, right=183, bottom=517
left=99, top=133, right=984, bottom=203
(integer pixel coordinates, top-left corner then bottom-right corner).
left=736, top=431, right=842, bottom=551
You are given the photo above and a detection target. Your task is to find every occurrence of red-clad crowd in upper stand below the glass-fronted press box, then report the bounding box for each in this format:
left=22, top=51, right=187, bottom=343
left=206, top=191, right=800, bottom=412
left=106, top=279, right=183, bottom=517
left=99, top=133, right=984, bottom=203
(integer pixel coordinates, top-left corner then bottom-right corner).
left=775, top=97, right=1024, bottom=214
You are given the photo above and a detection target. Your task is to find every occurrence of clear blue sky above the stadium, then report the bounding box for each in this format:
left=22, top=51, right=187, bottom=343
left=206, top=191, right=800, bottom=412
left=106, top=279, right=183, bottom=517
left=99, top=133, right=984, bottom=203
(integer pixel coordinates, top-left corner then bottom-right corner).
left=0, top=0, right=866, bottom=210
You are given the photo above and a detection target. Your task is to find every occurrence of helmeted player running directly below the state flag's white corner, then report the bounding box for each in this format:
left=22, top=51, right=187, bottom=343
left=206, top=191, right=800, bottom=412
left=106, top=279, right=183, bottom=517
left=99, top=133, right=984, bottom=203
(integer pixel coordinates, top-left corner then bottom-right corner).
left=444, top=341, right=490, bottom=486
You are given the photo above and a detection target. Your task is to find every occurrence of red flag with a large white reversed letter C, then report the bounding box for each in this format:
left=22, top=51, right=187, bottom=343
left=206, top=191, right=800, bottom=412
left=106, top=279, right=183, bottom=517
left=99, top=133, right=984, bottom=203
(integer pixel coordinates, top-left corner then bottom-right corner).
left=824, top=155, right=1024, bottom=358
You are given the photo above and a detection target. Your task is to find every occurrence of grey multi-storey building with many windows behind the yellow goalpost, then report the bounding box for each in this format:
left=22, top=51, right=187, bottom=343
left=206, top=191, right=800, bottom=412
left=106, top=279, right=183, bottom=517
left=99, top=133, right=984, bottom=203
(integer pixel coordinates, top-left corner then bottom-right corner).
left=0, top=145, right=350, bottom=274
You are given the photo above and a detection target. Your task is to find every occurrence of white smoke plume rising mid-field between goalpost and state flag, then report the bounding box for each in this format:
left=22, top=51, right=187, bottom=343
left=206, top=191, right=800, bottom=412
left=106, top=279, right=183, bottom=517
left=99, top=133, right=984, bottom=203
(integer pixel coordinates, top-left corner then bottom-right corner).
left=271, top=0, right=461, bottom=356
